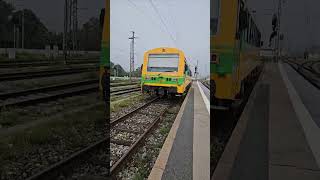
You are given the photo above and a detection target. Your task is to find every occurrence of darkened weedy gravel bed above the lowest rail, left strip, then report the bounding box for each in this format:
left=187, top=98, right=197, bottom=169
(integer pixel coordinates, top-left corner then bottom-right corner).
left=0, top=104, right=107, bottom=180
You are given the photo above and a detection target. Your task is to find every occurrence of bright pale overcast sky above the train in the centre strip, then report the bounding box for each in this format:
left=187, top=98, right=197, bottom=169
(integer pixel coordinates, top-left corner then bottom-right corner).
left=111, top=0, right=210, bottom=76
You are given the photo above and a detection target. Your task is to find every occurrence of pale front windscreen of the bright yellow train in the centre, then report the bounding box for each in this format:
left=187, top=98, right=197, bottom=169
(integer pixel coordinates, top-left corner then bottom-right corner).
left=147, top=54, right=179, bottom=72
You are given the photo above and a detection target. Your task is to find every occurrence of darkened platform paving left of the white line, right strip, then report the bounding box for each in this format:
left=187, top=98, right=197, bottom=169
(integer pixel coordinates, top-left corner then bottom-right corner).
left=212, top=63, right=320, bottom=180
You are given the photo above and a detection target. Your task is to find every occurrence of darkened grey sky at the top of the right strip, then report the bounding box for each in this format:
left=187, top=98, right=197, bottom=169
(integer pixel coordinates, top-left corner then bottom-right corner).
left=247, top=0, right=320, bottom=53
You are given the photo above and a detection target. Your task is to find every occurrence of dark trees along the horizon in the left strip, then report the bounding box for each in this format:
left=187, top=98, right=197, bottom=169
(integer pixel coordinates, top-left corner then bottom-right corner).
left=0, top=0, right=101, bottom=51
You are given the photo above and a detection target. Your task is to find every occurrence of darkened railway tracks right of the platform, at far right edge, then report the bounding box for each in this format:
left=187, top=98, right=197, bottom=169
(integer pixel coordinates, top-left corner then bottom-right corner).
left=284, top=60, right=320, bottom=89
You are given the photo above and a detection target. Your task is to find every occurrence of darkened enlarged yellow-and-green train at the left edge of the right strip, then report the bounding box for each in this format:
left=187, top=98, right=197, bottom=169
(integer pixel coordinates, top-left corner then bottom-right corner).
left=210, top=0, right=262, bottom=110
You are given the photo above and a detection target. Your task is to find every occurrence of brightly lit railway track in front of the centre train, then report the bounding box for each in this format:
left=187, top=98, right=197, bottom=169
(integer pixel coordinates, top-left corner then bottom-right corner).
left=110, top=98, right=174, bottom=176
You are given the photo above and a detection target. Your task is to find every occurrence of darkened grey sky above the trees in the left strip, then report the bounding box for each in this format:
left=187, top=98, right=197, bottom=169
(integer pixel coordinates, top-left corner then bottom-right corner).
left=5, top=0, right=105, bottom=32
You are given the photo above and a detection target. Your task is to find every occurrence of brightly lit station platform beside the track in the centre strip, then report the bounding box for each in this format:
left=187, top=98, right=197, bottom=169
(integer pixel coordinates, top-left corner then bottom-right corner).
left=148, top=81, right=210, bottom=180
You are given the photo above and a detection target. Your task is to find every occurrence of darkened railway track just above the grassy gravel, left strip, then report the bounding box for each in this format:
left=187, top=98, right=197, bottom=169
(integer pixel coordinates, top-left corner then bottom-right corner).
left=0, top=80, right=99, bottom=109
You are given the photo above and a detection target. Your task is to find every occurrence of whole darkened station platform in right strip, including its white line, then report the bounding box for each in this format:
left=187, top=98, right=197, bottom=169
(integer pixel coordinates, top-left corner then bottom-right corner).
left=211, top=62, right=320, bottom=180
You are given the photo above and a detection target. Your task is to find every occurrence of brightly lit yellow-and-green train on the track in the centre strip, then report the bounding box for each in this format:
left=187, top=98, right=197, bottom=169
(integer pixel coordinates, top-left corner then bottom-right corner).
left=141, top=47, right=192, bottom=95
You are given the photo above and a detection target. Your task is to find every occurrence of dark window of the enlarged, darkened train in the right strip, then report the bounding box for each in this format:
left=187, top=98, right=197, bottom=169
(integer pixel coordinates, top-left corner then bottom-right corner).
left=210, top=0, right=220, bottom=35
